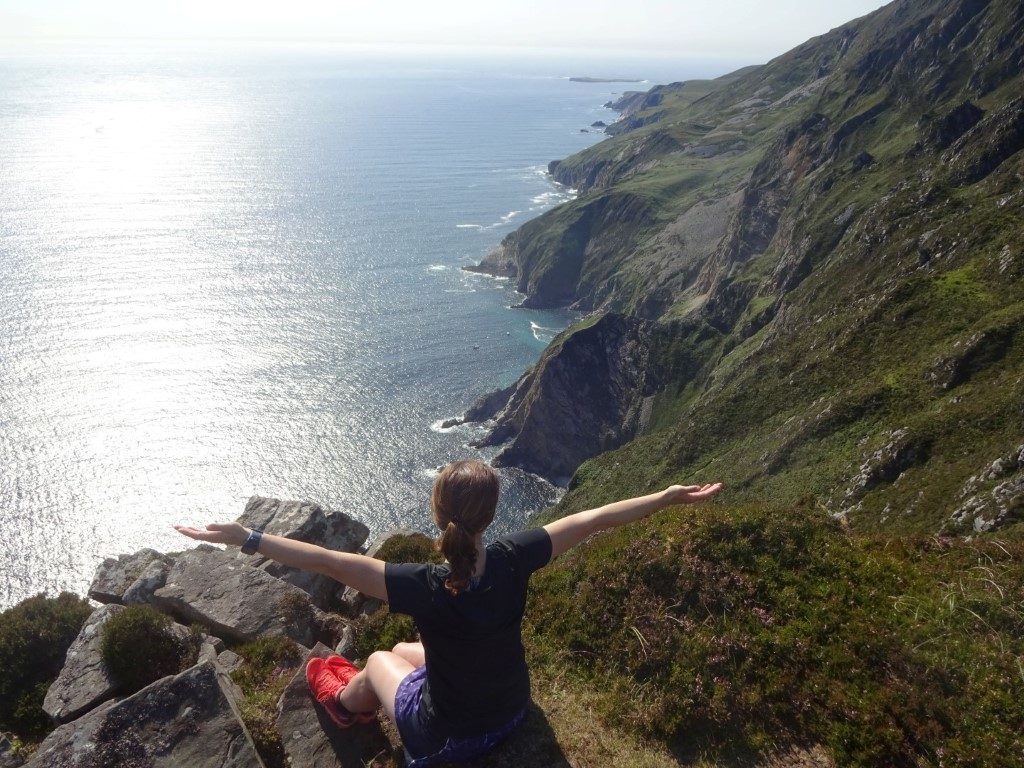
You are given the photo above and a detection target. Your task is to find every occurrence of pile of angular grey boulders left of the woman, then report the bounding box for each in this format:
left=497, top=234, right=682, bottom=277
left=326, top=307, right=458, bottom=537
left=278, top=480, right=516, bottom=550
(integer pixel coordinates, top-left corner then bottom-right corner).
left=24, top=497, right=400, bottom=768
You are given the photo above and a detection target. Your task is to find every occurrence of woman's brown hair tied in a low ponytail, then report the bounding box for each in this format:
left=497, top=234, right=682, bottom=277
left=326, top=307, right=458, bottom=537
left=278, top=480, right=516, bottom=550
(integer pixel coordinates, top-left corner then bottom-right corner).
left=430, top=459, right=498, bottom=595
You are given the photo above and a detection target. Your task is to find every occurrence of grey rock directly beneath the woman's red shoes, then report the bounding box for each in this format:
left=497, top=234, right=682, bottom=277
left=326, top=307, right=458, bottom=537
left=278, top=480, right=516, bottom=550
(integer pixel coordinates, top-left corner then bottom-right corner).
left=278, top=643, right=390, bottom=768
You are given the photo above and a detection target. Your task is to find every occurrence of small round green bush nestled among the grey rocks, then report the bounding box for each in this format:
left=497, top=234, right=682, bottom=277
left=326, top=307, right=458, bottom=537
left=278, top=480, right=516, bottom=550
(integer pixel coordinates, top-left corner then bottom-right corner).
left=100, top=605, right=199, bottom=693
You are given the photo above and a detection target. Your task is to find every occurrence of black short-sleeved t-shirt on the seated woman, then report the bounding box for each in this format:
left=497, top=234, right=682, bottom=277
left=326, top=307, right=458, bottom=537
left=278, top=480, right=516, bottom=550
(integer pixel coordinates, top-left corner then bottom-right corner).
left=384, top=528, right=551, bottom=738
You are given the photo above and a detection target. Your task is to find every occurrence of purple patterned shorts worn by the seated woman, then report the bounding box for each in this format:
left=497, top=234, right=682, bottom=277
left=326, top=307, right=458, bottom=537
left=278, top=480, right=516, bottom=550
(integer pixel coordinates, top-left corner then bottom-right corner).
left=394, top=666, right=526, bottom=768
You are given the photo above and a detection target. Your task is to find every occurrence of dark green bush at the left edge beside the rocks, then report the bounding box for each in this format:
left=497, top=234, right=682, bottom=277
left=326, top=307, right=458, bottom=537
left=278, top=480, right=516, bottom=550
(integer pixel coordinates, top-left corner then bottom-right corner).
left=0, top=592, right=92, bottom=740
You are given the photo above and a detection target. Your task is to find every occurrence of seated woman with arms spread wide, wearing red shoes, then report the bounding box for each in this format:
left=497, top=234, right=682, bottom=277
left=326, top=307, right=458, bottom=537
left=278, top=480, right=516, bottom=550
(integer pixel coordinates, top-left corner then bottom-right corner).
left=175, top=461, right=721, bottom=768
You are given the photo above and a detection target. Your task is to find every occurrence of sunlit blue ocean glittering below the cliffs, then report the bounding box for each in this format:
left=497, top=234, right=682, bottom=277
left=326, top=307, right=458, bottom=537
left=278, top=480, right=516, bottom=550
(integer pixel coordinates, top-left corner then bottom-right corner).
left=0, top=44, right=725, bottom=607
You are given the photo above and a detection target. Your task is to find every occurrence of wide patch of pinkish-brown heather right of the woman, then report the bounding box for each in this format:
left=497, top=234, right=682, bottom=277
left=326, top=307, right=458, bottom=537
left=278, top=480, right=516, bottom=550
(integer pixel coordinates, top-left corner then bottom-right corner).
left=524, top=508, right=1024, bottom=766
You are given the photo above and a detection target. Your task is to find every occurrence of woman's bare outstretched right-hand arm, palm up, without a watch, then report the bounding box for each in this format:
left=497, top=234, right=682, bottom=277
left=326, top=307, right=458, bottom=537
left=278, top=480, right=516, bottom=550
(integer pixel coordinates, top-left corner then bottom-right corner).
left=544, top=482, right=722, bottom=560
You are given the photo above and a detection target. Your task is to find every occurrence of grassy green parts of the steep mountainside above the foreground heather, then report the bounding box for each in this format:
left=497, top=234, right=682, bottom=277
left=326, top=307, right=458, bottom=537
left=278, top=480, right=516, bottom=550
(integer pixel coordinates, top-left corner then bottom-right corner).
left=528, top=2, right=1024, bottom=534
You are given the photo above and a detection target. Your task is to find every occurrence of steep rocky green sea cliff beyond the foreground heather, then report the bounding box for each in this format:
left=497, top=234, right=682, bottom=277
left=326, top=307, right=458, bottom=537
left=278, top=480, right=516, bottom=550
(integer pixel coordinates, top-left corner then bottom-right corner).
left=466, top=0, right=1024, bottom=532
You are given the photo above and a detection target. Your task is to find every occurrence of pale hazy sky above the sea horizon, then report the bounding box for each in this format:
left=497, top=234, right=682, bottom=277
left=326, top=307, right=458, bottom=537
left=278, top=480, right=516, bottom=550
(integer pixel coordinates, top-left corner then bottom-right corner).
left=0, top=0, right=885, bottom=60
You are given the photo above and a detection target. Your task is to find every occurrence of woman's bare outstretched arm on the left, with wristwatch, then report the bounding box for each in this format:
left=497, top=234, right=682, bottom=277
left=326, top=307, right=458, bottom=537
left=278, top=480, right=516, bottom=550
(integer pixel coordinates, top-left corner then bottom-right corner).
left=174, top=522, right=387, bottom=600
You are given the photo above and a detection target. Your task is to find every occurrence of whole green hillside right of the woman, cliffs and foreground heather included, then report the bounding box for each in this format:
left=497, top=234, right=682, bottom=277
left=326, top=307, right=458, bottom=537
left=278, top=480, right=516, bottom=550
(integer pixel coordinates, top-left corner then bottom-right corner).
left=448, top=0, right=1024, bottom=766
